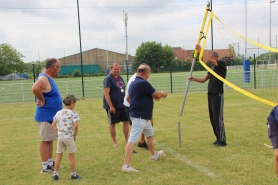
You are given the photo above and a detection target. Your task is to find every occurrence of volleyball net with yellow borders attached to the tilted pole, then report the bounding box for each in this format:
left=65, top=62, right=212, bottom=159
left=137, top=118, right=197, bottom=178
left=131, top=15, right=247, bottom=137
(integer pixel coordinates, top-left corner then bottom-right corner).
left=197, top=4, right=278, bottom=106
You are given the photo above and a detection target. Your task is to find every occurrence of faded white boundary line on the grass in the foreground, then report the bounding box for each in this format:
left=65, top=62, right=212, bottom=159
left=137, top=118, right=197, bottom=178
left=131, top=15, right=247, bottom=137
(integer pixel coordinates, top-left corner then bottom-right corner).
left=155, top=142, right=216, bottom=177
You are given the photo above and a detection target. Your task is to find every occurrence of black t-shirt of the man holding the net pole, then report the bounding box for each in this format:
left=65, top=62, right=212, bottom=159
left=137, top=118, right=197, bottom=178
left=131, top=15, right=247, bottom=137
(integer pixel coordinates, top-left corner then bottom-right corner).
left=208, top=60, right=227, bottom=94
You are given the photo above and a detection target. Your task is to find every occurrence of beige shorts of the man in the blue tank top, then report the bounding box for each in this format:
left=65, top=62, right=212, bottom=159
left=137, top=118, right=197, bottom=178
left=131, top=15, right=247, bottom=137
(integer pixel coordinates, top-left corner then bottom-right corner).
left=37, top=122, right=57, bottom=141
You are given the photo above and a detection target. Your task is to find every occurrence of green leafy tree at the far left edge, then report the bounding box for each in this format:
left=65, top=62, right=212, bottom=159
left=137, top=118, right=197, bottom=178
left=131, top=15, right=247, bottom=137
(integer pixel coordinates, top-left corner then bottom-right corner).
left=0, top=44, right=24, bottom=76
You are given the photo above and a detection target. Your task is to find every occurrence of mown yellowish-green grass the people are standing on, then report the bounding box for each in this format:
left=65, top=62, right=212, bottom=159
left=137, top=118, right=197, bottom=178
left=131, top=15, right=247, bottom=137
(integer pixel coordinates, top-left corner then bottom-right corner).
left=0, top=90, right=278, bottom=185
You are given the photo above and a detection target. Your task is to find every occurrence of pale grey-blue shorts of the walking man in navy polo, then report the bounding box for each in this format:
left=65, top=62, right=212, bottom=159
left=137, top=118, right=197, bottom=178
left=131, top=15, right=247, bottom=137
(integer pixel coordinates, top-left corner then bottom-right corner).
left=128, top=117, right=154, bottom=143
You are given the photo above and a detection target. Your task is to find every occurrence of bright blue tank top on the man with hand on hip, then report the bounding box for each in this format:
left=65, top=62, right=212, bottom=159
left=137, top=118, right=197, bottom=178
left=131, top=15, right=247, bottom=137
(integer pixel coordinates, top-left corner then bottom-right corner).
left=35, top=74, right=62, bottom=122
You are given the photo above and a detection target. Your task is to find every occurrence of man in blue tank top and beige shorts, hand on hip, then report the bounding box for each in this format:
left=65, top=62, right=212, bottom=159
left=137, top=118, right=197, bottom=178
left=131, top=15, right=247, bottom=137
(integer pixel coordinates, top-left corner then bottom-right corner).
left=32, top=58, right=62, bottom=173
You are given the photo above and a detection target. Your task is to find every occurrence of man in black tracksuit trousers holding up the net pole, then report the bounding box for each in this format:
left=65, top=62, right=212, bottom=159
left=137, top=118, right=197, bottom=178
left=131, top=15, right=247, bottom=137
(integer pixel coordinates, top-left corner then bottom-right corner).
left=188, top=45, right=227, bottom=146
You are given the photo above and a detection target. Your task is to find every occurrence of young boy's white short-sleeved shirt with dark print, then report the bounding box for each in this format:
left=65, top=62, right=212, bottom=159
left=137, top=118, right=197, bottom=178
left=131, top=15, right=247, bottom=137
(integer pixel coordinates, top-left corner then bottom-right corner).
left=53, top=109, right=80, bottom=138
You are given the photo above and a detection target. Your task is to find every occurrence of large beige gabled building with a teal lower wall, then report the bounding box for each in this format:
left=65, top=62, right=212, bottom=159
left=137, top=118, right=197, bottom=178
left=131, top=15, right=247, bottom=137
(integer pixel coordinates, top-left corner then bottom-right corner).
left=58, top=48, right=135, bottom=74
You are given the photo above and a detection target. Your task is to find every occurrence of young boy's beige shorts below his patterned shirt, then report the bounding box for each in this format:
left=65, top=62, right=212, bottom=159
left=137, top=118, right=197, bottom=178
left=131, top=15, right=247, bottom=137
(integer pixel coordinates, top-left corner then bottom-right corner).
left=56, top=136, right=77, bottom=154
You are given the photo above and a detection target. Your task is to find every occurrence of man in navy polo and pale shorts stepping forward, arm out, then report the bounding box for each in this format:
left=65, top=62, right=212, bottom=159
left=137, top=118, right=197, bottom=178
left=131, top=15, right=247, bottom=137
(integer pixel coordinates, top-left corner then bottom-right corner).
left=122, top=64, right=167, bottom=171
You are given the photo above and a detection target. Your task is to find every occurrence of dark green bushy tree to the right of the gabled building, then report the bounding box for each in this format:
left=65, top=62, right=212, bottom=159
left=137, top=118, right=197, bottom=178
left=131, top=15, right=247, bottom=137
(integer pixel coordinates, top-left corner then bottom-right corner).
left=134, top=41, right=174, bottom=72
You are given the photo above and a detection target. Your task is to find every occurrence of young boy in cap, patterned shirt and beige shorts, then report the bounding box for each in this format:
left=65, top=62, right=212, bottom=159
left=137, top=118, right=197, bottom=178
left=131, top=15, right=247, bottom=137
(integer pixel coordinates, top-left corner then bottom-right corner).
left=52, top=94, right=81, bottom=181
